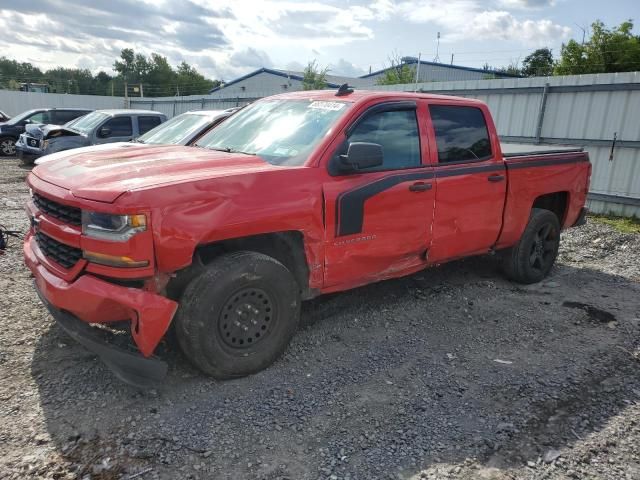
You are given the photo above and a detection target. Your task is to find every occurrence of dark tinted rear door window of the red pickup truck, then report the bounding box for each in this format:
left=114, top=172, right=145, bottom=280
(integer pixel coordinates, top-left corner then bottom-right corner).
left=429, top=105, right=491, bottom=163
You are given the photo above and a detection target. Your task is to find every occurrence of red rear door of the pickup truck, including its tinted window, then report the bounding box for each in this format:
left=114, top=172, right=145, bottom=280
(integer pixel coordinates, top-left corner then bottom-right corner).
left=429, top=101, right=507, bottom=263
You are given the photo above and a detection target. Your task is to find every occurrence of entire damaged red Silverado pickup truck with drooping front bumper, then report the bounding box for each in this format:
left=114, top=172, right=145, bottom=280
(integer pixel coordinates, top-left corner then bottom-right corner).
left=24, top=88, right=591, bottom=384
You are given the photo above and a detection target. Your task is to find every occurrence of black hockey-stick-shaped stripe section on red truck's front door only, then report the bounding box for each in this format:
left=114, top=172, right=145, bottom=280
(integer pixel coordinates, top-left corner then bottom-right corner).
left=336, top=170, right=433, bottom=237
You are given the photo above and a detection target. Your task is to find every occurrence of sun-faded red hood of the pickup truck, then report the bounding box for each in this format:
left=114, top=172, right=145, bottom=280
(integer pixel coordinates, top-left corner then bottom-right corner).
left=32, top=144, right=278, bottom=203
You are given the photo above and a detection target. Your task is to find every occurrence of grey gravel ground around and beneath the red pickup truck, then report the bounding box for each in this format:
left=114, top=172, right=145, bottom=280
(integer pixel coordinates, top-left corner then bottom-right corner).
left=0, top=159, right=640, bottom=480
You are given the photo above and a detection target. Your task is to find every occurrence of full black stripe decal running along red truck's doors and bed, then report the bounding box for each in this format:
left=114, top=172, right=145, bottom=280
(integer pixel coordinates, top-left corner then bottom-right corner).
left=336, top=155, right=588, bottom=237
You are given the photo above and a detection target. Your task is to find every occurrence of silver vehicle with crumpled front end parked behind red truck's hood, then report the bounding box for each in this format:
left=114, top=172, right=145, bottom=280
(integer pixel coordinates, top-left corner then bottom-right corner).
left=16, top=110, right=167, bottom=165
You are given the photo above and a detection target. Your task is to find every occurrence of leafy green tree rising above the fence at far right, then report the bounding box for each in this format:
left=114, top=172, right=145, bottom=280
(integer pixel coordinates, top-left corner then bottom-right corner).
left=554, top=20, right=640, bottom=75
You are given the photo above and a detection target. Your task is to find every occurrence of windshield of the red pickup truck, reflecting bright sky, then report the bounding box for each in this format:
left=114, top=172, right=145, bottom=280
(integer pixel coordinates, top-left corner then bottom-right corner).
left=196, top=99, right=350, bottom=165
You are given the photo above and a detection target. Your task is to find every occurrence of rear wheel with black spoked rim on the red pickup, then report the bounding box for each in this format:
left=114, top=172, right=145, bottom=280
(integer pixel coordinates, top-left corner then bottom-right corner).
left=502, top=208, right=560, bottom=284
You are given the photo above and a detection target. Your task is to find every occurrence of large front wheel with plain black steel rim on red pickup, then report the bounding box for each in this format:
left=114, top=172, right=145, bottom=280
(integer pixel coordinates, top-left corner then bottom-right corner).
left=175, top=252, right=300, bottom=379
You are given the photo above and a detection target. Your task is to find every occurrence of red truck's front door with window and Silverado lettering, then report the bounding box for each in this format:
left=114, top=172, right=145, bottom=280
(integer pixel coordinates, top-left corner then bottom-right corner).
left=323, top=102, right=435, bottom=287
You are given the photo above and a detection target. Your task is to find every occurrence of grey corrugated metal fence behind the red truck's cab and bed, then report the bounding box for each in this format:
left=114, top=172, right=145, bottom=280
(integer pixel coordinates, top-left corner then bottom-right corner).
left=376, top=72, right=640, bottom=217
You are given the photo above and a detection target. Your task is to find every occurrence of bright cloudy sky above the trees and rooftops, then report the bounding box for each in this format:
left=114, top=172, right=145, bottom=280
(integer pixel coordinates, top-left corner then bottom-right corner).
left=0, top=0, right=640, bottom=81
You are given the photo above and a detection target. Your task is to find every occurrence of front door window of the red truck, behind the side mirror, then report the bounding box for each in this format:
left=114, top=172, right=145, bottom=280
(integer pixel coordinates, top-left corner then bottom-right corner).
left=347, top=110, right=421, bottom=171
